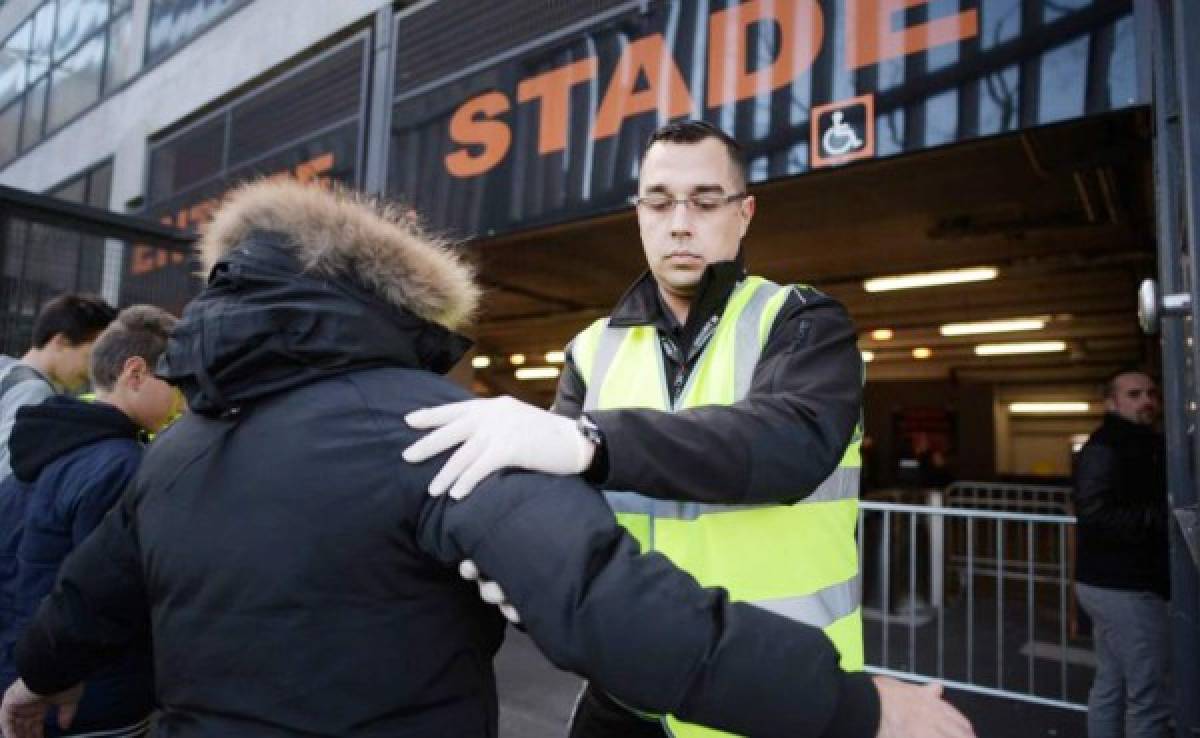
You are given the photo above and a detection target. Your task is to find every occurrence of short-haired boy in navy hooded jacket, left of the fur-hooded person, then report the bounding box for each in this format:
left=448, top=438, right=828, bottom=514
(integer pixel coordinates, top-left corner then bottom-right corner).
left=0, top=305, right=180, bottom=737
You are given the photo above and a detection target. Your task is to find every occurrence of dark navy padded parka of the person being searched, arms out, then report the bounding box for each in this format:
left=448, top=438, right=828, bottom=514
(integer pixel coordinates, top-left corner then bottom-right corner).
left=11, top=182, right=878, bottom=738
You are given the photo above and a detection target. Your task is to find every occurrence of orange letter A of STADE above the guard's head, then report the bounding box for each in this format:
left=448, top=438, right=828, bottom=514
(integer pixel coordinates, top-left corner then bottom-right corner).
left=592, top=34, right=691, bottom=140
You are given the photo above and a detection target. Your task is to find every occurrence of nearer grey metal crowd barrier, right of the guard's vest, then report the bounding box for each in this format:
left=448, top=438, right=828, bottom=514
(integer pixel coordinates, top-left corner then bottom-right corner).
left=859, top=494, right=1094, bottom=710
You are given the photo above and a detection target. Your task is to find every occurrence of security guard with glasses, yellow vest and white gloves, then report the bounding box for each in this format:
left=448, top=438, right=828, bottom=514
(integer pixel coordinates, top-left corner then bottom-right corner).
left=404, top=121, right=921, bottom=738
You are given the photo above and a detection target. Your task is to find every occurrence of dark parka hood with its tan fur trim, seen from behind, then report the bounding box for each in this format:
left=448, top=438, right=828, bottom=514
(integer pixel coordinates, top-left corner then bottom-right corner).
left=157, top=180, right=479, bottom=415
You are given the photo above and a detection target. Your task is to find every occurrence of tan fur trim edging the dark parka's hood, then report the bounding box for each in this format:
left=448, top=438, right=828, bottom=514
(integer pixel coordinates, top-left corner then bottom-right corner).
left=199, top=178, right=480, bottom=329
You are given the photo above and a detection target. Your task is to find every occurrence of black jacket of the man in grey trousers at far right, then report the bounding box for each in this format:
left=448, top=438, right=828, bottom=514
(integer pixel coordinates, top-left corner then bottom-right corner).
left=1074, top=413, right=1170, bottom=598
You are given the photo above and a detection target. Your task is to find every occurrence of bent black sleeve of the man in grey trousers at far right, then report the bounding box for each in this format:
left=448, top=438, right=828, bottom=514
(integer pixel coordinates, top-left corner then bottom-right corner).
left=1074, top=443, right=1166, bottom=545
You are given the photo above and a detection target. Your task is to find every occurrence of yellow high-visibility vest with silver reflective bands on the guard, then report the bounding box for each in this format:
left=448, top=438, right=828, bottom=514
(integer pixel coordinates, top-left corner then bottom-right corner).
left=570, top=277, right=863, bottom=738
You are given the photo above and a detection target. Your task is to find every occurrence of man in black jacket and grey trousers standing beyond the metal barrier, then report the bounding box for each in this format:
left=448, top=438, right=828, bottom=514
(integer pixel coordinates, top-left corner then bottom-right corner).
left=1075, top=370, right=1170, bottom=738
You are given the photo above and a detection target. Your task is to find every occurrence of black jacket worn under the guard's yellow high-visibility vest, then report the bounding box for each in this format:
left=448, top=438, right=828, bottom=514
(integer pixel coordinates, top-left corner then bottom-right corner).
left=554, top=260, right=863, bottom=504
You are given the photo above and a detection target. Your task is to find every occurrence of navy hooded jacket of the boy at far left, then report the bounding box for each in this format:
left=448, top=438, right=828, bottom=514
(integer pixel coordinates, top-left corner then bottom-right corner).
left=0, top=396, right=154, bottom=732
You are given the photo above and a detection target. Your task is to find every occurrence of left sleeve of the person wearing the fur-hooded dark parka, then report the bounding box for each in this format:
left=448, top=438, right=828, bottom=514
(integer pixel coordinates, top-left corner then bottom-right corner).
left=16, top=487, right=150, bottom=695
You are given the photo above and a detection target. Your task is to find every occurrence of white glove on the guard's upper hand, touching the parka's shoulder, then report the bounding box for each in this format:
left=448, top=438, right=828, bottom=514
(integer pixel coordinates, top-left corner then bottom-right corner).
left=404, top=397, right=596, bottom=499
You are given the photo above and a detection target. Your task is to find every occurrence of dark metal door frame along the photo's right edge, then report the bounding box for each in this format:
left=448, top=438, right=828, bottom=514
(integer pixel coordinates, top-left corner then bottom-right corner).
left=1135, top=0, right=1200, bottom=738
